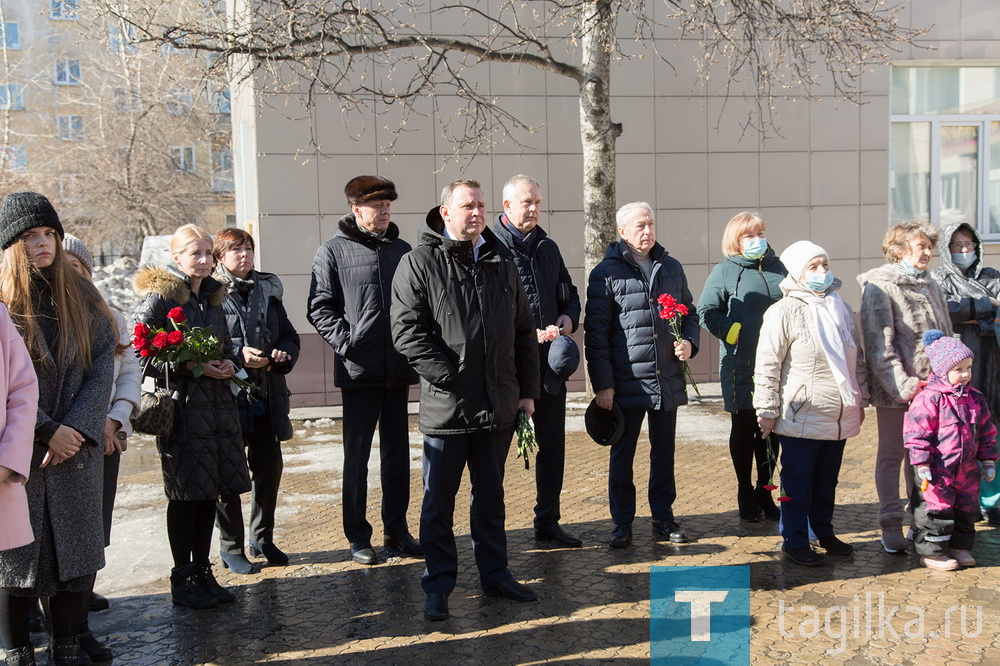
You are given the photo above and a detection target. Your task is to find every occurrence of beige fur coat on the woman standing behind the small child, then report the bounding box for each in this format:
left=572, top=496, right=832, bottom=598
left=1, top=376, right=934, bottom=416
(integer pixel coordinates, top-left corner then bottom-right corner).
left=858, top=264, right=952, bottom=409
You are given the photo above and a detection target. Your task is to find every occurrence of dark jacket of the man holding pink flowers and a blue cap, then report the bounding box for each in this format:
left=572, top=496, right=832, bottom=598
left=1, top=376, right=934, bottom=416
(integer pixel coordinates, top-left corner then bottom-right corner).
left=493, top=216, right=580, bottom=382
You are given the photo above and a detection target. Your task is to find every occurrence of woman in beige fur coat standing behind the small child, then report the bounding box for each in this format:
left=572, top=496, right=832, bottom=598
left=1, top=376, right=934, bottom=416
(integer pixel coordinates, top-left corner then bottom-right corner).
left=858, top=221, right=952, bottom=553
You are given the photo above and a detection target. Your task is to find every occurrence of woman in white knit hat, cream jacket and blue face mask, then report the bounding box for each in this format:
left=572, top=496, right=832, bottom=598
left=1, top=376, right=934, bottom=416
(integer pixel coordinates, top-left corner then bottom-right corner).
left=753, top=241, right=868, bottom=566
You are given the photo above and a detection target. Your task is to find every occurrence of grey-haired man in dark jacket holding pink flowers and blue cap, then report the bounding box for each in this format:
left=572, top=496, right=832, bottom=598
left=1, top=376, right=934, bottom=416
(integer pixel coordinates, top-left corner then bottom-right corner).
left=493, top=174, right=583, bottom=548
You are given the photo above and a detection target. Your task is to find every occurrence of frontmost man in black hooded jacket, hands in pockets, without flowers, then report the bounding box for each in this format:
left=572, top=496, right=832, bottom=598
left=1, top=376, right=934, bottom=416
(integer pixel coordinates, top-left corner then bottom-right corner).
left=392, top=179, right=538, bottom=620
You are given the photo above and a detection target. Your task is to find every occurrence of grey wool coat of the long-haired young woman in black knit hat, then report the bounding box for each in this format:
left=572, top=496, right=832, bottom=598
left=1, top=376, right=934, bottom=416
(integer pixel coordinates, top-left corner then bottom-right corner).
left=0, top=269, right=117, bottom=596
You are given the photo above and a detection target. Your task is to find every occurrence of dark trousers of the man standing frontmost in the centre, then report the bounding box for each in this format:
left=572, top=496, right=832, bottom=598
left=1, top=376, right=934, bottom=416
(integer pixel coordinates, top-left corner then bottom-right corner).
left=420, top=428, right=514, bottom=595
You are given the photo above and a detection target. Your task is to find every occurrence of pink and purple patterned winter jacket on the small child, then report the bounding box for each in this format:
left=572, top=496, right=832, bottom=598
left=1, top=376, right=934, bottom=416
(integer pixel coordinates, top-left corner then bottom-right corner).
left=903, top=374, right=997, bottom=512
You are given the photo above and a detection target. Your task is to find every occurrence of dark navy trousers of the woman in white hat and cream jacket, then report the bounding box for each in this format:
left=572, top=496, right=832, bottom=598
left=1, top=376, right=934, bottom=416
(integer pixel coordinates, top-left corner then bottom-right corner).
left=778, top=435, right=846, bottom=550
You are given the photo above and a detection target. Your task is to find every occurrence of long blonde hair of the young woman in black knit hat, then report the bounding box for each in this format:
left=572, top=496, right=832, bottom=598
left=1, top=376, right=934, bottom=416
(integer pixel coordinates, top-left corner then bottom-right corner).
left=0, top=240, right=118, bottom=371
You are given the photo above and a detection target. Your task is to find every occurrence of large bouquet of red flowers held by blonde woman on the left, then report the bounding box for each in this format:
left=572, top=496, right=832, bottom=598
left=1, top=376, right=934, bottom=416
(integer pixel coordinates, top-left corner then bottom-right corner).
left=132, top=307, right=256, bottom=400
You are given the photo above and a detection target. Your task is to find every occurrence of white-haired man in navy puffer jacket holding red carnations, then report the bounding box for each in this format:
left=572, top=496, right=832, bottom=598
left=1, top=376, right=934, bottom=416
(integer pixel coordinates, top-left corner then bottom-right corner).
left=583, top=202, right=699, bottom=548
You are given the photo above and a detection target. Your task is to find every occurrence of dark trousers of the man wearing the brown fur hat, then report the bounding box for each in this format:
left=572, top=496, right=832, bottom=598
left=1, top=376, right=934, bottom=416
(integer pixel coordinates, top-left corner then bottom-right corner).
left=341, top=386, right=410, bottom=543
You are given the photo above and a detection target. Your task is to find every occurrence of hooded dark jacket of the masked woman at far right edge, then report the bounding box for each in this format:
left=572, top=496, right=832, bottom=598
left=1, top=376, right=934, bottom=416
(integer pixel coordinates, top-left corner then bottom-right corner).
left=931, top=222, right=1000, bottom=421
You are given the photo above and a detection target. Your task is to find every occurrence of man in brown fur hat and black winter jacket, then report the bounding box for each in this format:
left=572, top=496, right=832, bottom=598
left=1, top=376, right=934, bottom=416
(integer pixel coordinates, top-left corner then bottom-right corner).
left=308, top=176, right=423, bottom=564
